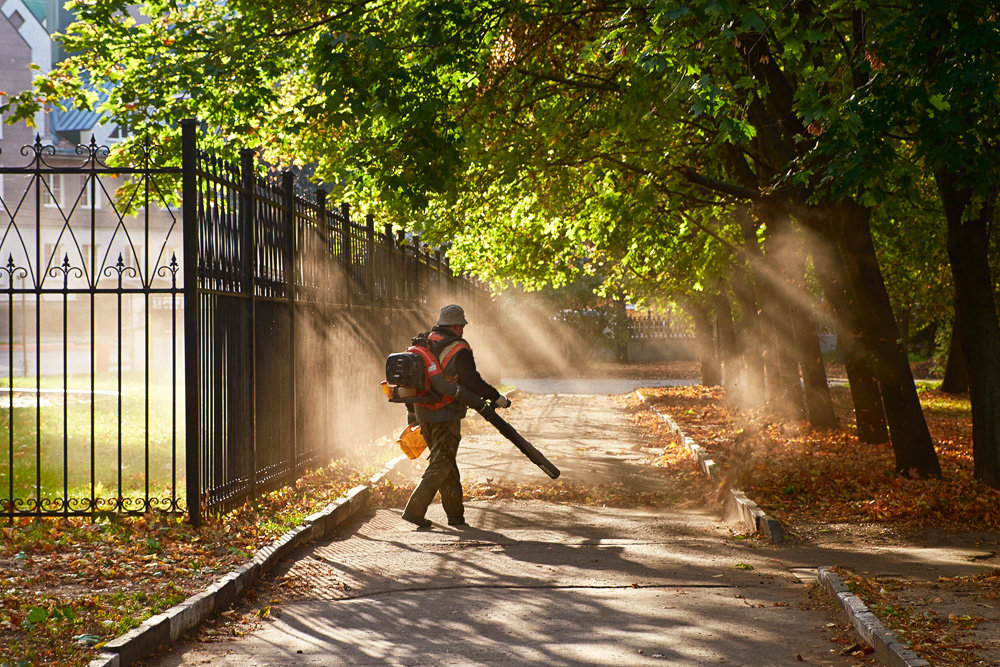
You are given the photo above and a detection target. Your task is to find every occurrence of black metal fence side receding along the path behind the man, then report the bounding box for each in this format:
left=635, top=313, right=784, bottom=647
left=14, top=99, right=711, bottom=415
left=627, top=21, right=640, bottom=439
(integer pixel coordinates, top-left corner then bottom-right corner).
left=183, top=123, right=489, bottom=517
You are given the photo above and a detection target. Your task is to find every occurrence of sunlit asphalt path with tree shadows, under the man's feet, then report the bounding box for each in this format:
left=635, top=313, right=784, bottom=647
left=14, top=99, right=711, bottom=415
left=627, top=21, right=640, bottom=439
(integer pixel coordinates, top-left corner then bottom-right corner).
left=150, top=395, right=857, bottom=666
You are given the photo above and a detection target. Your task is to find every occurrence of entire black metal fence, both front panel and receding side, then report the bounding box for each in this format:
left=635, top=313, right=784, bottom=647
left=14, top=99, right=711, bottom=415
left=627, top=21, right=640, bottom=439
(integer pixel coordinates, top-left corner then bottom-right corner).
left=0, top=122, right=492, bottom=522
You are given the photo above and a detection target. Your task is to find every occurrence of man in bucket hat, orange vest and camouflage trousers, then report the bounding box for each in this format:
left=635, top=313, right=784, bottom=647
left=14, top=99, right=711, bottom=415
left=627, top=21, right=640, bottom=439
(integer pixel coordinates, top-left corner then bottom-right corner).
left=403, top=304, right=510, bottom=528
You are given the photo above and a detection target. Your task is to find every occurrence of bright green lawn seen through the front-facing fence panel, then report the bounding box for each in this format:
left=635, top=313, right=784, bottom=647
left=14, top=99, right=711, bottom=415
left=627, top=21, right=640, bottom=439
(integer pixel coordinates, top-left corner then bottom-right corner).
left=0, top=377, right=184, bottom=509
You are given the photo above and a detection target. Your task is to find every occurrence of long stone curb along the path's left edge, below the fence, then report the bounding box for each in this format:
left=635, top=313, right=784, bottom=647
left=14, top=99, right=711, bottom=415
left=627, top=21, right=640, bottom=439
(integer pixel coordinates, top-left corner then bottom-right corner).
left=89, top=456, right=409, bottom=667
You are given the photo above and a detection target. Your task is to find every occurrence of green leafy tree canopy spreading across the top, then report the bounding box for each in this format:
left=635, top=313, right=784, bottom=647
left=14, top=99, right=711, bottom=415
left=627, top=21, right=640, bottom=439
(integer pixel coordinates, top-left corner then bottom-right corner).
left=4, top=0, right=1000, bottom=317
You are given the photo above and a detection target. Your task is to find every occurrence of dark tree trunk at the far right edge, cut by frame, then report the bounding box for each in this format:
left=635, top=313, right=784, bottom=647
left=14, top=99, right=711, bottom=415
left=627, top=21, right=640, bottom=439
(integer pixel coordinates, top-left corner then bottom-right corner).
left=935, top=171, right=1000, bottom=488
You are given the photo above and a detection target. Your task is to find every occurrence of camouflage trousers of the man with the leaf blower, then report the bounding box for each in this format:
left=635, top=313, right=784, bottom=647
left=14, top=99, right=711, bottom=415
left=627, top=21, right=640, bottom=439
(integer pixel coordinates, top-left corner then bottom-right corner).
left=403, top=419, right=465, bottom=519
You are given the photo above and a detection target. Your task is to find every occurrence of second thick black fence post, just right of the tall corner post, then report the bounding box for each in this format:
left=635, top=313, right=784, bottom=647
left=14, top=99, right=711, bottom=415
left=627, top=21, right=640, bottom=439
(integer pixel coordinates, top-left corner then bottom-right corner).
left=240, top=148, right=257, bottom=498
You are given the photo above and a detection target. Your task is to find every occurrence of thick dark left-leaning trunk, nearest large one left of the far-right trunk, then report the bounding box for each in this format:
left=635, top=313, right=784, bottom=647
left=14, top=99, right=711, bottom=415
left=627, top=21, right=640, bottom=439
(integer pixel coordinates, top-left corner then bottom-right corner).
left=814, top=201, right=941, bottom=477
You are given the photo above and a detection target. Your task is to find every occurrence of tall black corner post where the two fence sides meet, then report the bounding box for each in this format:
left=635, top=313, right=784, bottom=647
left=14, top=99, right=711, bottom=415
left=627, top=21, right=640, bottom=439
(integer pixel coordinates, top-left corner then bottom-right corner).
left=181, top=118, right=201, bottom=527
